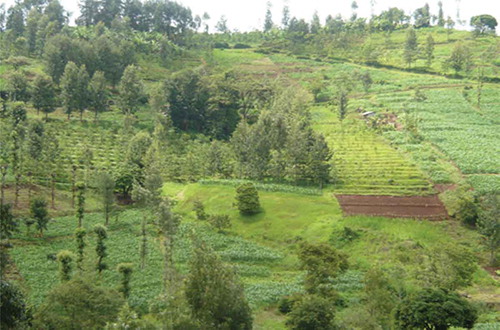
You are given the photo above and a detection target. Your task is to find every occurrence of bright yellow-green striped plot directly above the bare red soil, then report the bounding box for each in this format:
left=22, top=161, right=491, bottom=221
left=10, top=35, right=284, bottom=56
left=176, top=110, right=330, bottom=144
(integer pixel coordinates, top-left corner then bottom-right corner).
left=312, top=107, right=433, bottom=195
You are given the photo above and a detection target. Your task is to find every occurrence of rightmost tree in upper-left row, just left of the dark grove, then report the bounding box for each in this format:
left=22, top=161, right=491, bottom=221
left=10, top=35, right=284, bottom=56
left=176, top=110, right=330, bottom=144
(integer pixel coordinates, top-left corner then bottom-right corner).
left=118, top=65, right=144, bottom=115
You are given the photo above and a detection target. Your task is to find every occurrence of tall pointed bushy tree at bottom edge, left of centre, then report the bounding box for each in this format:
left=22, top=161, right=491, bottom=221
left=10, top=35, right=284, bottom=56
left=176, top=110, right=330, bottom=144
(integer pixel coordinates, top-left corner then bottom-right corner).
left=186, top=241, right=252, bottom=329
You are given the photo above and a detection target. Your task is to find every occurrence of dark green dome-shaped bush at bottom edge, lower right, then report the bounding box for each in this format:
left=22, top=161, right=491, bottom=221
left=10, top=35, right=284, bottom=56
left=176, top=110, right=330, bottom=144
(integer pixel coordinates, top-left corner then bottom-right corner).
left=395, top=289, right=477, bottom=329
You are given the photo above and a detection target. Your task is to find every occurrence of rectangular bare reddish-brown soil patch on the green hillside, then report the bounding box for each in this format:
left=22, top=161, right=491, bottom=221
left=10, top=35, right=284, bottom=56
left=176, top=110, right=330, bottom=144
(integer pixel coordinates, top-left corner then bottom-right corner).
left=335, top=195, right=448, bottom=220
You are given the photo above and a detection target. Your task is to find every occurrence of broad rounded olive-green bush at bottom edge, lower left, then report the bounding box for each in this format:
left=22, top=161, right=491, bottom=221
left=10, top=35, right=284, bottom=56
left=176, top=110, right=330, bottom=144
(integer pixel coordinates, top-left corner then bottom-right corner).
left=34, top=277, right=123, bottom=329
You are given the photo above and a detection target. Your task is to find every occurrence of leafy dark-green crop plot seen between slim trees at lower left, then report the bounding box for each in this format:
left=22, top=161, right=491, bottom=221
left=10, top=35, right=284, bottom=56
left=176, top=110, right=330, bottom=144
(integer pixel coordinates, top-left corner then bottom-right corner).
left=11, top=210, right=301, bottom=312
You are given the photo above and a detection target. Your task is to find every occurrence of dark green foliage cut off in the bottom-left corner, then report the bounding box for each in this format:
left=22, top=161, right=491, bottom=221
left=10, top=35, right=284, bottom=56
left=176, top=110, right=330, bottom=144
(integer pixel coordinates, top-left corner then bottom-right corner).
left=0, top=278, right=30, bottom=329
